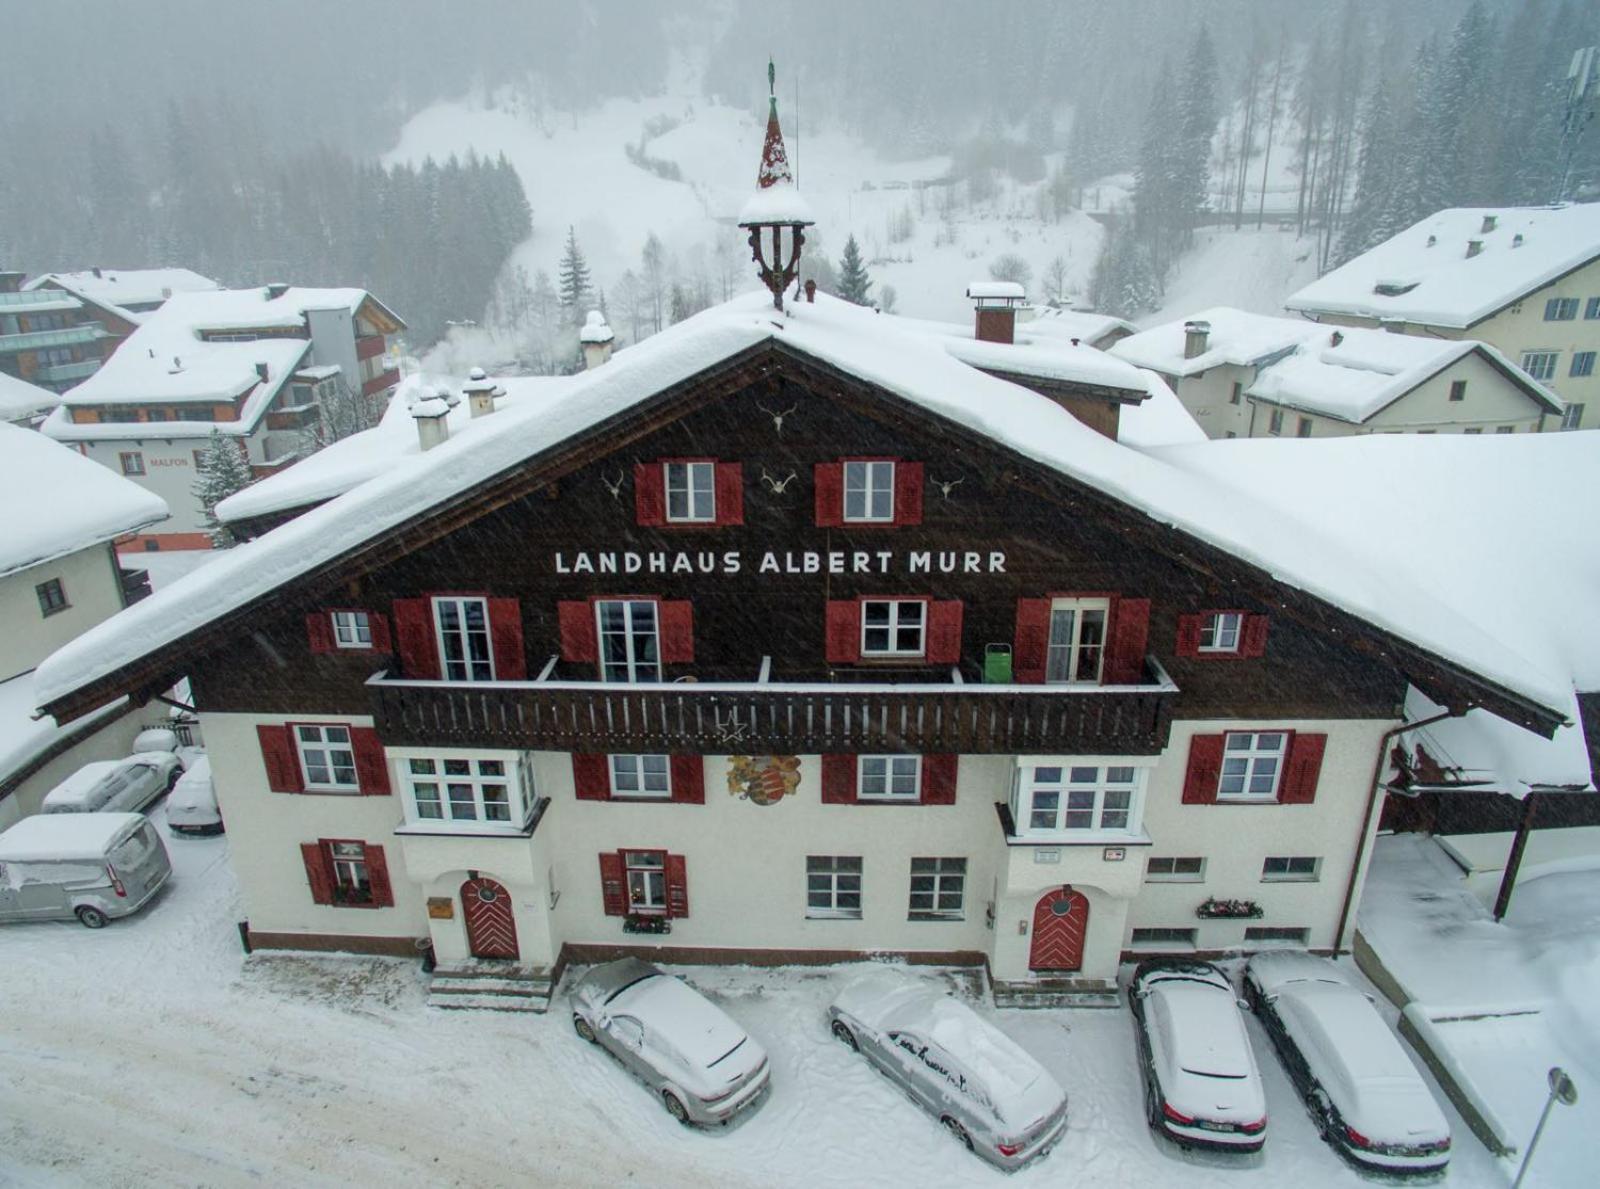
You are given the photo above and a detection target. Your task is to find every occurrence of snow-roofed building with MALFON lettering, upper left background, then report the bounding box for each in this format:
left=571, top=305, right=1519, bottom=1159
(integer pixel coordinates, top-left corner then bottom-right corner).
left=38, top=285, right=403, bottom=549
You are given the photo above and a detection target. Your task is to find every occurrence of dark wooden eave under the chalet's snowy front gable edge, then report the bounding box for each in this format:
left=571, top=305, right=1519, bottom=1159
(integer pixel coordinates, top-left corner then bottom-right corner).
left=43, top=339, right=1565, bottom=736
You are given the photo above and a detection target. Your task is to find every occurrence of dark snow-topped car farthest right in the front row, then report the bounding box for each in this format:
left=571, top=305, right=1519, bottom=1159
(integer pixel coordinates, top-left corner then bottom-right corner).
left=1245, top=954, right=1450, bottom=1173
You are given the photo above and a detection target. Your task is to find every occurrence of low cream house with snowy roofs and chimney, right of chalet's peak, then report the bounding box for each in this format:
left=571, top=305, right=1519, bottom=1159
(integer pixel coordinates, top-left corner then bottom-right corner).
left=1110, top=306, right=1562, bottom=438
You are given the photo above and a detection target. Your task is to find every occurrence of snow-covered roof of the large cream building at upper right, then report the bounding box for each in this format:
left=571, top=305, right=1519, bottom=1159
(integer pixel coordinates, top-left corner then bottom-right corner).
left=1283, top=203, right=1600, bottom=328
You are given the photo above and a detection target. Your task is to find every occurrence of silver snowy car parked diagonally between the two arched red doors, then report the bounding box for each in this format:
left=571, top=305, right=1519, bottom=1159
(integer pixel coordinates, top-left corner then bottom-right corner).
left=827, top=971, right=1067, bottom=1170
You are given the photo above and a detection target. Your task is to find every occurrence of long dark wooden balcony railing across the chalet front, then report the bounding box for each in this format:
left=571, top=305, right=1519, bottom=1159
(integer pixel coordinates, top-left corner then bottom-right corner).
left=368, top=658, right=1178, bottom=755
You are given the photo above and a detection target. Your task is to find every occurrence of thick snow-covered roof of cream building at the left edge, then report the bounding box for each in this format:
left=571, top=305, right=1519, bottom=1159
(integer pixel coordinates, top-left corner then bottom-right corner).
left=0, top=424, right=168, bottom=576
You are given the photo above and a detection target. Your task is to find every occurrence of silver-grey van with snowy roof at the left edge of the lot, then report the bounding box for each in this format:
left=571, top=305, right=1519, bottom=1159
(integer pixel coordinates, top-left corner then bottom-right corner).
left=0, top=813, right=173, bottom=928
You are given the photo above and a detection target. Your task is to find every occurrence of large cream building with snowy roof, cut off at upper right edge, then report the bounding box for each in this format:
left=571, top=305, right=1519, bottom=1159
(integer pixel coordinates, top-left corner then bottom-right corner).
left=1283, top=203, right=1600, bottom=429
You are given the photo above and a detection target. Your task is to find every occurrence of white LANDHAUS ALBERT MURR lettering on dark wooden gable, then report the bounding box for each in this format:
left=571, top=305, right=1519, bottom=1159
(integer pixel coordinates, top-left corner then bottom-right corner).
left=554, top=549, right=1005, bottom=574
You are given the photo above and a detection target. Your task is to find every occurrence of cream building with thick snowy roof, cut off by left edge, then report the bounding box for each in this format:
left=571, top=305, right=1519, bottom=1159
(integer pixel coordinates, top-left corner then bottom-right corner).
left=0, top=426, right=166, bottom=829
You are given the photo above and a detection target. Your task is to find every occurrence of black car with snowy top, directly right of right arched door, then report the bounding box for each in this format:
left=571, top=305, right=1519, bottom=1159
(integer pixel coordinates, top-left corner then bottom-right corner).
left=1128, top=959, right=1267, bottom=1152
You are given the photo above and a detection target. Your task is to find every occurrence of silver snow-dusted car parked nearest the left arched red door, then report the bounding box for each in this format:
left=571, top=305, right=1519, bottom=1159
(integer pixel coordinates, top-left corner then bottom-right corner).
left=571, top=959, right=771, bottom=1125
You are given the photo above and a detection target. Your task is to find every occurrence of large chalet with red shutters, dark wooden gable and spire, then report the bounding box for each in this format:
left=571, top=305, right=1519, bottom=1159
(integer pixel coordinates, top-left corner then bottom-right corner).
left=37, top=100, right=1570, bottom=1005
